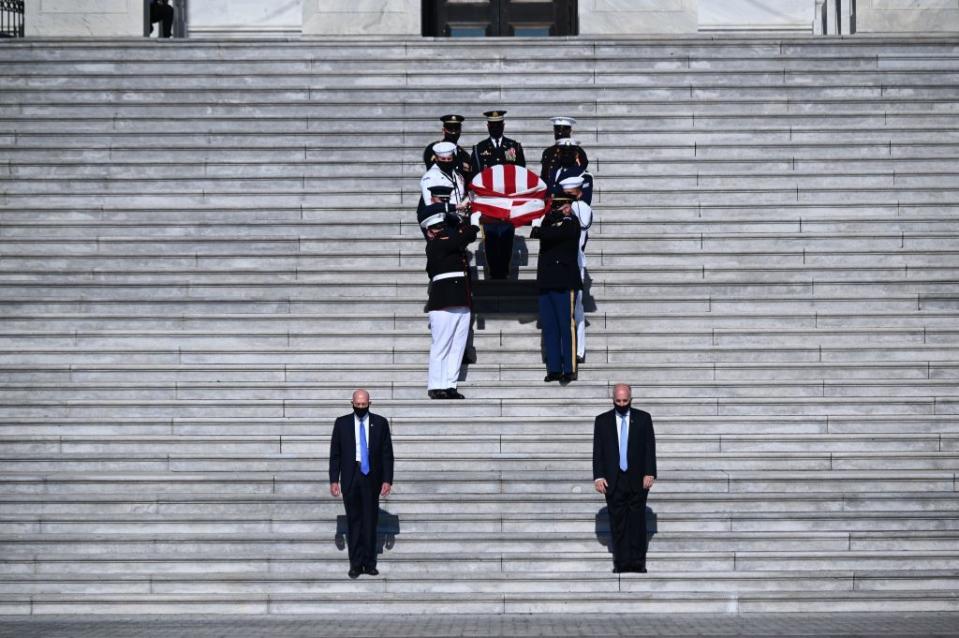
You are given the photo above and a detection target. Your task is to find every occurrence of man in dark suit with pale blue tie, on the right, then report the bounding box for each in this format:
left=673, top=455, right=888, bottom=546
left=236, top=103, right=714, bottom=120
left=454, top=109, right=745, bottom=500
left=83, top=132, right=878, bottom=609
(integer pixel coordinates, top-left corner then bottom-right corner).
left=593, top=383, right=656, bottom=574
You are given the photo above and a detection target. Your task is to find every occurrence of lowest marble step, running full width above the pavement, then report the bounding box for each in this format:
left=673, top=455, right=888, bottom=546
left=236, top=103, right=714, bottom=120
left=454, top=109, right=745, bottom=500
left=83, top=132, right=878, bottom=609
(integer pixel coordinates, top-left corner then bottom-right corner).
left=0, top=591, right=959, bottom=615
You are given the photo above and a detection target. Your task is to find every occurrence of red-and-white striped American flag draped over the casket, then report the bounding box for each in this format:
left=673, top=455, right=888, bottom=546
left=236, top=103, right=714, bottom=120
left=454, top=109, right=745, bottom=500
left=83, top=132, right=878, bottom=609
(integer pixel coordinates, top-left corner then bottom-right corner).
left=470, top=164, right=546, bottom=226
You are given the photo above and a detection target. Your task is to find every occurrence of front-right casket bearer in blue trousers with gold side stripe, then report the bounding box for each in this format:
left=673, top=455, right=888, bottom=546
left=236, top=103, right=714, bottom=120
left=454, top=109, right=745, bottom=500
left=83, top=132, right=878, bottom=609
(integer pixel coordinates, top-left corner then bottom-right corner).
left=530, top=193, right=583, bottom=384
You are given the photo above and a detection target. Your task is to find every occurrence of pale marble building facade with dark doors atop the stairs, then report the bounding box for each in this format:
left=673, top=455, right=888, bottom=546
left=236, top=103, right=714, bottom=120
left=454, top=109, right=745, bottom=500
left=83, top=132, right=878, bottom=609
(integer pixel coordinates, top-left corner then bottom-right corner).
left=25, top=0, right=959, bottom=38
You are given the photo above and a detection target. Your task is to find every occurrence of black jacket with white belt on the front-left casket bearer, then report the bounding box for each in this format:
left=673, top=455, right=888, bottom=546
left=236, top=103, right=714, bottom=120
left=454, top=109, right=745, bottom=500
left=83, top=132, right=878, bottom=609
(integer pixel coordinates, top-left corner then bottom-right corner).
left=426, top=224, right=478, bottom=312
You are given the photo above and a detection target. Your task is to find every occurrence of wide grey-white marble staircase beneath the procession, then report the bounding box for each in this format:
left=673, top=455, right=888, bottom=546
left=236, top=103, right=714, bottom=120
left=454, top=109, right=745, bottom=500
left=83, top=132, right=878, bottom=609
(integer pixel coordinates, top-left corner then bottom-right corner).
left=0, top=37, right=959, bottom=614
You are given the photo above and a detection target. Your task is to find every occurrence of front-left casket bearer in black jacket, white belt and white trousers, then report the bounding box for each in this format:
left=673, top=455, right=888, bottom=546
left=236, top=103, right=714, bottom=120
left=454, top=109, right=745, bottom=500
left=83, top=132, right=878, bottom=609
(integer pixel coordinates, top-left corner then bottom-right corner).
left=421, top=212, right=480, bottom=399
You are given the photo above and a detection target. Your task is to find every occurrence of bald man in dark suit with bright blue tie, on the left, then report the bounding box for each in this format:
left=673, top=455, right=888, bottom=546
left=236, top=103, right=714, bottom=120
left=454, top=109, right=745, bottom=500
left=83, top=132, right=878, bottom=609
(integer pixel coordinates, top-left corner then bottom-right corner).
left=330, top=390, right=393, bottom=578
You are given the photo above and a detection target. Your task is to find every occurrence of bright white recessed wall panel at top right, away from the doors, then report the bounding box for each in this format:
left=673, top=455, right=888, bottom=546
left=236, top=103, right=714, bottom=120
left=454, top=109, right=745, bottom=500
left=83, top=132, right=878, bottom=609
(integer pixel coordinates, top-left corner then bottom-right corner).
left=699, top=0, right=816, bottom=32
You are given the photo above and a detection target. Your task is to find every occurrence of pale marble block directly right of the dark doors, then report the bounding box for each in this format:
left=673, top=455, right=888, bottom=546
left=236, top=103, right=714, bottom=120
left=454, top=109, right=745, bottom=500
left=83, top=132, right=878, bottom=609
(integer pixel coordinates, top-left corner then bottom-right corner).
left=579, top=0, right=698, bottom=35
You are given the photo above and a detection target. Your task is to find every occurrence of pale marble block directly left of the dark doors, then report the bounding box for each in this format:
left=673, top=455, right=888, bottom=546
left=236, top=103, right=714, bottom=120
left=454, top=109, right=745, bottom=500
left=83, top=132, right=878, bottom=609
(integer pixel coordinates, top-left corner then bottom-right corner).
left=303, top=0, right=422, bottom=35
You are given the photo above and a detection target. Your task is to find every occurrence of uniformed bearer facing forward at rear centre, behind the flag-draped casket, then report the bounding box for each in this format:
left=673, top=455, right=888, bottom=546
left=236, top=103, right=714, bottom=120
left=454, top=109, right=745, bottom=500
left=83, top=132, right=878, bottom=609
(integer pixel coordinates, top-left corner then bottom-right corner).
left=473, top=111, right=526, bottom=279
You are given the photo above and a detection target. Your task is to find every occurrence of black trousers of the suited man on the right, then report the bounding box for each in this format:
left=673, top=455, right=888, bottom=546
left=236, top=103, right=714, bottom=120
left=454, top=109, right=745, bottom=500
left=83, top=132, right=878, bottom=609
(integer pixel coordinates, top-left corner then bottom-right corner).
left=606, top=471, right=649, bottom=569
